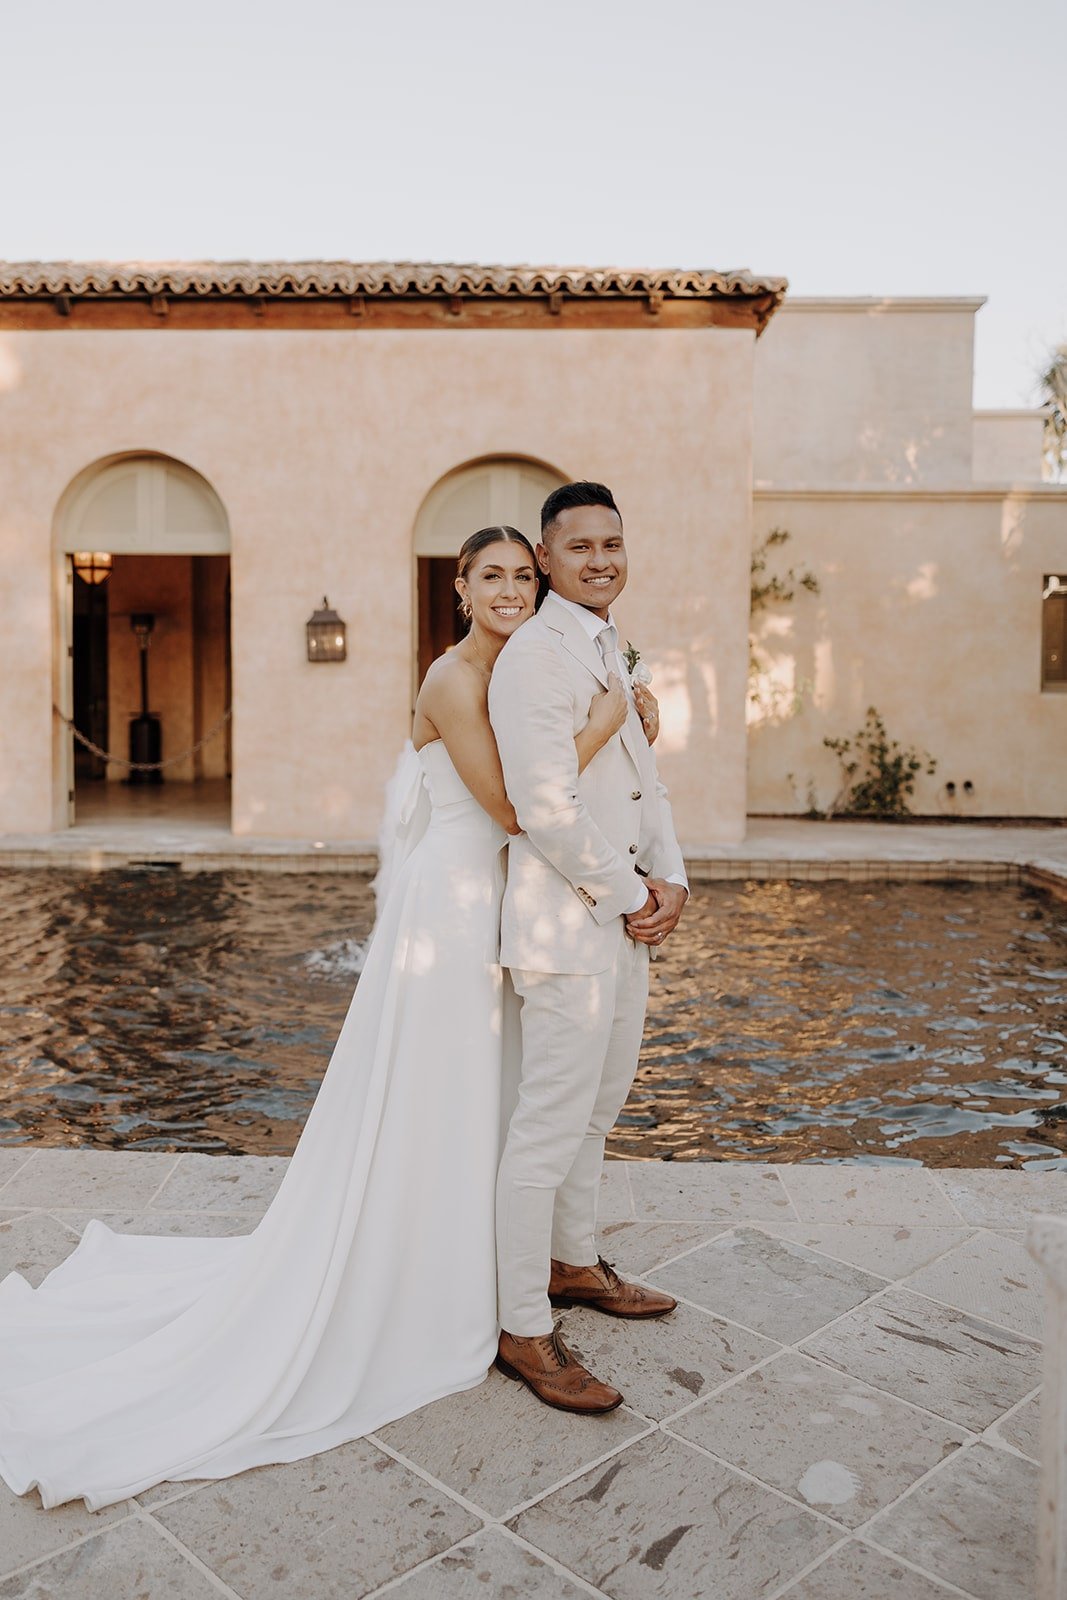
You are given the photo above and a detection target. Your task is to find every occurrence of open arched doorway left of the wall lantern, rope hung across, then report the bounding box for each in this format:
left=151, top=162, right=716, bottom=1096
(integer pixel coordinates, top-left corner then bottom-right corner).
left=53, top=453, right=230, bottom=826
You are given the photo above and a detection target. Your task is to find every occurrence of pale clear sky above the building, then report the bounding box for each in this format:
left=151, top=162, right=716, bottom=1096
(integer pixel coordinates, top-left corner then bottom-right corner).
left=0, top=0, right=1067, bottom=406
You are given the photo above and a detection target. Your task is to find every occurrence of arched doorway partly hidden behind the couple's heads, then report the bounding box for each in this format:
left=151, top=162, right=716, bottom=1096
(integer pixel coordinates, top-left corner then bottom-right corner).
left=414, top=456, right=566, bottom=693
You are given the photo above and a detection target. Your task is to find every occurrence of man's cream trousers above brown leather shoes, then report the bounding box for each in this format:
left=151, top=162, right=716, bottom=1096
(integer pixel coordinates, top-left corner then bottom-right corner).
left=496, top=938, right=648, bottom=1338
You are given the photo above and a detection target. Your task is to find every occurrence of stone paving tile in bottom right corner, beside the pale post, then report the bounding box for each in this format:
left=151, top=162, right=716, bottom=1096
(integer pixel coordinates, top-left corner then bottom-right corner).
left=867, top=1443, right=1038, bottom=1600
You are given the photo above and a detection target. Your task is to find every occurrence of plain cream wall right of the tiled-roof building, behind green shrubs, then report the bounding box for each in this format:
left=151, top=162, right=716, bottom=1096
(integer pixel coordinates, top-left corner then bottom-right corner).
left=749, top=299, right=1067, bottom=818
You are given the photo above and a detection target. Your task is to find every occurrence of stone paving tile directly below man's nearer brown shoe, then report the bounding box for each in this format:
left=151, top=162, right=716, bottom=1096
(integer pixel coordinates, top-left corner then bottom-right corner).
left=374, top=1371, right=648, bottom=1517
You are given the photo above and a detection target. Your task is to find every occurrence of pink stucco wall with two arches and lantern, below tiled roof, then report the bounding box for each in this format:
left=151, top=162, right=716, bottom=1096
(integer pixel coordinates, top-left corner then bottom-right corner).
left=0, top=330, right=753, bottom=845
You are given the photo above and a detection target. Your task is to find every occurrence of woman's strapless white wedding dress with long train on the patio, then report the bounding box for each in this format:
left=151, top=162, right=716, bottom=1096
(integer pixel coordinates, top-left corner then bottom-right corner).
left=0, top=741, right=506, bottom=1510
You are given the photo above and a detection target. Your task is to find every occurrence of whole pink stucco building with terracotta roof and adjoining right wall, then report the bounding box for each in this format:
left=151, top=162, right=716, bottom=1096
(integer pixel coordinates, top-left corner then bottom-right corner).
left=0, top=262, right=1067, bottom=848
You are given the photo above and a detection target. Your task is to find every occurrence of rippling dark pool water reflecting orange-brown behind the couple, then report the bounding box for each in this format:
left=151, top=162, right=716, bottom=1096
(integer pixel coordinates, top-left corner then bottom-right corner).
left=0, top=870, right=1067, bottom=1166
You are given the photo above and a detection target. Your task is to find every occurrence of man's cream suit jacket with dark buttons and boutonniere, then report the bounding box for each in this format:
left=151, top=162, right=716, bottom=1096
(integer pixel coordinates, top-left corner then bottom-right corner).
left=490, top=594, right=685, bottom=973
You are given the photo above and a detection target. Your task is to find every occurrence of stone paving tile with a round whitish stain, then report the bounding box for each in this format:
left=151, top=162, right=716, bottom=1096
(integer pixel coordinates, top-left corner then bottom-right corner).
left=670, top=1355, right=968, bottom=1528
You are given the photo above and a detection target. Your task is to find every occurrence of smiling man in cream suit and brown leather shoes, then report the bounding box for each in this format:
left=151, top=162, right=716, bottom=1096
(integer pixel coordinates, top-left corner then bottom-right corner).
left=490, top=483, right=688, bottom=1413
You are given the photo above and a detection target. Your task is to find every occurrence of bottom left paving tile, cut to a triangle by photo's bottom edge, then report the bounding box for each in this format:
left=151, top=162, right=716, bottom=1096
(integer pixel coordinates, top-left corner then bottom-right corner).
left=0, top=1512, right=219, bottom=1600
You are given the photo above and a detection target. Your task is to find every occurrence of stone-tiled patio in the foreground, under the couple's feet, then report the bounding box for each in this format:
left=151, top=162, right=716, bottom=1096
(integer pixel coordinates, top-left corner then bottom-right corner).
left=0, top=1147, right=1067, bottom=1600
